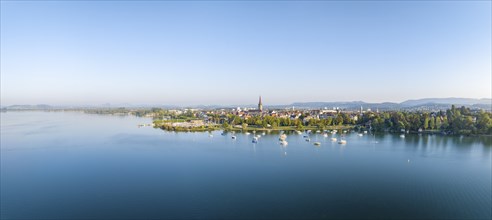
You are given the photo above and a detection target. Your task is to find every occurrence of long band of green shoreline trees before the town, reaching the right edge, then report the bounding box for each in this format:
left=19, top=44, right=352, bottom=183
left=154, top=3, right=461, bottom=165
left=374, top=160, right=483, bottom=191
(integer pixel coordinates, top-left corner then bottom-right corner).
left=209, top=105, right=492, bottom=135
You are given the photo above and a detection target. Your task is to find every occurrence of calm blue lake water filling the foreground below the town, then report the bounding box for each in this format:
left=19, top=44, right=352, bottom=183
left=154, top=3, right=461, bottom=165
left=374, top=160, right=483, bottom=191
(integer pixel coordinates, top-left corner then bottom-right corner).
left=0, top=112, right=492, bottom=219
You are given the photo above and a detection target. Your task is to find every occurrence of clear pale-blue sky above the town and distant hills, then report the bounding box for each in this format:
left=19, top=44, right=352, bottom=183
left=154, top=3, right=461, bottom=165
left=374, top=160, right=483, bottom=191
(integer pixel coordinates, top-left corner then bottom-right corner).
left=1, top=1, right=492, bottom=106
